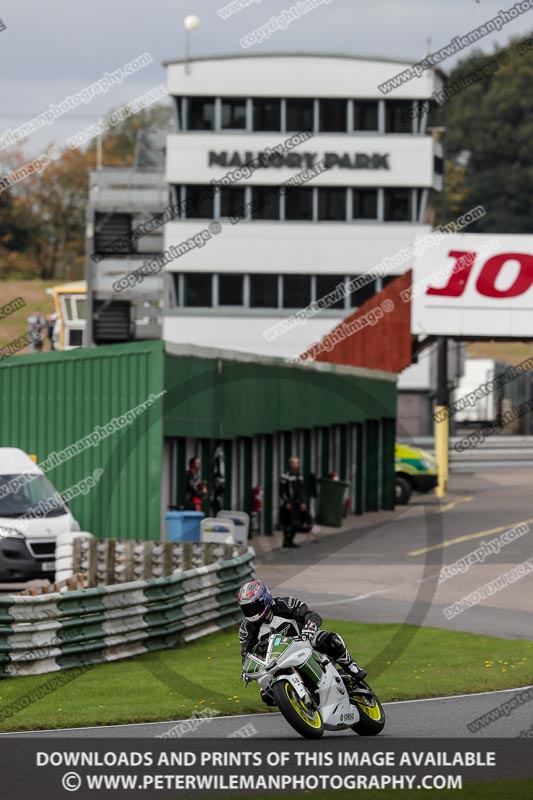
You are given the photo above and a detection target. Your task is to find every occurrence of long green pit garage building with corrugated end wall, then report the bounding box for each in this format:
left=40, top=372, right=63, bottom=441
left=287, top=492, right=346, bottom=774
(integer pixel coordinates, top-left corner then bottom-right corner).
left=0, top=341, right=397, bottom=540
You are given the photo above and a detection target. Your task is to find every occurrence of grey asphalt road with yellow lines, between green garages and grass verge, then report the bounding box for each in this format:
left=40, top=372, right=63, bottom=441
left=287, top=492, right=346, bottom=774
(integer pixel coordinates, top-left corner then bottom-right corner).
left=254, top=470, right=533, bottom=640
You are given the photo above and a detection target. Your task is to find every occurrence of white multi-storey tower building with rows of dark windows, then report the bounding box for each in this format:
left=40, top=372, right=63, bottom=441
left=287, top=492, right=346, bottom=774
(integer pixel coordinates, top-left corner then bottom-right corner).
left=163, top=54, right=442, bottom=357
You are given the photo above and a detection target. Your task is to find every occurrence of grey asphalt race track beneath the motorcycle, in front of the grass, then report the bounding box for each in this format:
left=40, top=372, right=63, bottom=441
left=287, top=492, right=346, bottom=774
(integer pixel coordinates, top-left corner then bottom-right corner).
left=0, top=687, right=533, bottom=740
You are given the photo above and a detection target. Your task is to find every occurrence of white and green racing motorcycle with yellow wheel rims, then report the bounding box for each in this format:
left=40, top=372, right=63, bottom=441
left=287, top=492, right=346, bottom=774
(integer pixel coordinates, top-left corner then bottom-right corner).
left=242, top=630, right=385, bottom=739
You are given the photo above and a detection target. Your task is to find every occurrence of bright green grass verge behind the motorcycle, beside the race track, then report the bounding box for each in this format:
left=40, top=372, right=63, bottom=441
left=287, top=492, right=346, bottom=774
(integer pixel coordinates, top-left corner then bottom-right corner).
left=0, top=620, right=533, bottom=731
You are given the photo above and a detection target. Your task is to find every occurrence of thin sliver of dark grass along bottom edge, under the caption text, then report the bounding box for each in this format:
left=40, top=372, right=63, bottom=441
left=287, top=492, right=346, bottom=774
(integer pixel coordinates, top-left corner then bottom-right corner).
left=212, top=780, right=533, bottom=800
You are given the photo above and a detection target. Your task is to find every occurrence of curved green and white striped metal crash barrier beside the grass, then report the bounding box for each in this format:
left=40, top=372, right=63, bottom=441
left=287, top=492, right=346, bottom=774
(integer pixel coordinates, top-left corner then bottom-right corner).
left=0, top=545, right=254, bottom=677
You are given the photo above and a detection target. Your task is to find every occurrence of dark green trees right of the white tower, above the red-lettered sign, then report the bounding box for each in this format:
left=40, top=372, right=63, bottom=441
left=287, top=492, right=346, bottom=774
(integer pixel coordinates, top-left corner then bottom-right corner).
left=446, top=39, right=533, bottom=233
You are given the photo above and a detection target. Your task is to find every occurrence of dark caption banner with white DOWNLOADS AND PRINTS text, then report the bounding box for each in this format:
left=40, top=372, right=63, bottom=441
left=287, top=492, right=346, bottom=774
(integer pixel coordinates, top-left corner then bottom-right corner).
left=0, top=736, right=533, bottom=800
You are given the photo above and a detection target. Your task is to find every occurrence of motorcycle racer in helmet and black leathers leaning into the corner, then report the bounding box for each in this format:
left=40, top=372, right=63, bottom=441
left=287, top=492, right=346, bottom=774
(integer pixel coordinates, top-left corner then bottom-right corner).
left=237, top=580, right=367, bottom=702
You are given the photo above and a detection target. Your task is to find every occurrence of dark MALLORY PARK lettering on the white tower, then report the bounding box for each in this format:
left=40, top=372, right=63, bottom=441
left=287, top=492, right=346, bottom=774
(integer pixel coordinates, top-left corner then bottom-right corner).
left=209, top=150, right=390, bottom=169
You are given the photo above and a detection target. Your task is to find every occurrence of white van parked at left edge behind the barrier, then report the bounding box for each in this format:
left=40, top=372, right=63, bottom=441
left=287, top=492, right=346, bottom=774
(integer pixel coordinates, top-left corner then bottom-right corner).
left=0, top=447, right=80, bottom=582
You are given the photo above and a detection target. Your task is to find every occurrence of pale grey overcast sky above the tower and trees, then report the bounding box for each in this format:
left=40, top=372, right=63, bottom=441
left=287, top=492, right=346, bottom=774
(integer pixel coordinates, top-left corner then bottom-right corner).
left=0, top=0, right=533, bottom=154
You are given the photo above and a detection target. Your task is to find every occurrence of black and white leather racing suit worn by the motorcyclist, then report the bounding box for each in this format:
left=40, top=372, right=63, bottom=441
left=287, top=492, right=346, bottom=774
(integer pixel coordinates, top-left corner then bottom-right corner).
left=239, top=597, right=352, bottom=666
